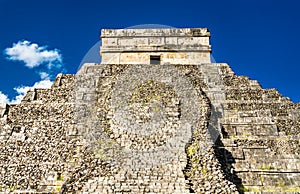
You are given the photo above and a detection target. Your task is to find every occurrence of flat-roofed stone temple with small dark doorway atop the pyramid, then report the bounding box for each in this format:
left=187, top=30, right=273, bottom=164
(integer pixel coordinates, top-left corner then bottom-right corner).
left=100, top=28, right=211, bottom=64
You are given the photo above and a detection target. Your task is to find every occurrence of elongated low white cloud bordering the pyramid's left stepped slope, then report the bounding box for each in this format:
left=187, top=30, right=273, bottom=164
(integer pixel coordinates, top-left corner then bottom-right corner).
left=8, top=80, right=53, bottom=104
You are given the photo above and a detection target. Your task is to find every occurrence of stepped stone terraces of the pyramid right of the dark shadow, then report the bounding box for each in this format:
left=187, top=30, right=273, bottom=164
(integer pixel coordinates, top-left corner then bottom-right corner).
left=218, top=64, right=300, bottom=193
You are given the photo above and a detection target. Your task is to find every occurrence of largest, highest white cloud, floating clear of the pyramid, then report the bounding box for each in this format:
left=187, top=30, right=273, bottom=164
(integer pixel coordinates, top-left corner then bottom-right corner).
left=4, top=40, right=62, bottom=69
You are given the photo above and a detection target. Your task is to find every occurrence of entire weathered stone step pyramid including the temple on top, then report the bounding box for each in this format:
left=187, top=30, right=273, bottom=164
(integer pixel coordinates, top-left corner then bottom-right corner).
left=0, top=28, right=300, bottom=193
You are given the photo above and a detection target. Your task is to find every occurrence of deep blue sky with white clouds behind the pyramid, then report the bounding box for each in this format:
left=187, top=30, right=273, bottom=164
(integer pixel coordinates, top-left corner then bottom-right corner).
left=0, top=0, right=300, bottom=102
